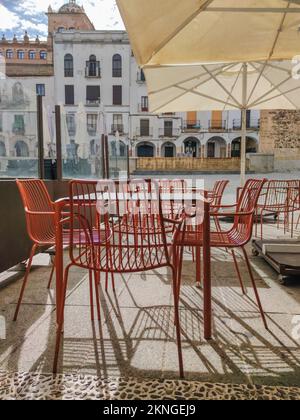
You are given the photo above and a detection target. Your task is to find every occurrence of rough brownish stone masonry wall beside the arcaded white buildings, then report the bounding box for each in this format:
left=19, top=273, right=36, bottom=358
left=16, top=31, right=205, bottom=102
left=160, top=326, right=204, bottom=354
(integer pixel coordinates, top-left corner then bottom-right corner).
left=260, top=111, right=300, bottom=171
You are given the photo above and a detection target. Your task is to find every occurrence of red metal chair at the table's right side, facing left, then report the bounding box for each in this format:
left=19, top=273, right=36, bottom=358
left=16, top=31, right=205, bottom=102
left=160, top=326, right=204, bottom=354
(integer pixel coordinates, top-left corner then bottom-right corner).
left=176, top=179, right=268, bottom=329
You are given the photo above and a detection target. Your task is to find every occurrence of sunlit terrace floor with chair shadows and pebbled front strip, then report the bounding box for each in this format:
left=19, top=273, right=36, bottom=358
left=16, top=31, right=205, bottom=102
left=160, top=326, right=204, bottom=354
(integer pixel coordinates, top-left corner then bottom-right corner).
left=0, top=218, right=300, bottom=399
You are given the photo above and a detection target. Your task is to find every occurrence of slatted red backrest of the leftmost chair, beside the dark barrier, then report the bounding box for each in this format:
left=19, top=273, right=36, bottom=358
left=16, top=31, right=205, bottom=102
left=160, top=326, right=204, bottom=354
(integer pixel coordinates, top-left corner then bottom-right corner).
left=16, top=179, right=55, bottom=245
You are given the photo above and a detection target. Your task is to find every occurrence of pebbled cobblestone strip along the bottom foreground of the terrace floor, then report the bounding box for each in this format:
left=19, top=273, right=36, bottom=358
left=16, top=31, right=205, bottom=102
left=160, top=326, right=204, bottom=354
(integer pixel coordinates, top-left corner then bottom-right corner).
left=0, top=372, right=300, bottom=401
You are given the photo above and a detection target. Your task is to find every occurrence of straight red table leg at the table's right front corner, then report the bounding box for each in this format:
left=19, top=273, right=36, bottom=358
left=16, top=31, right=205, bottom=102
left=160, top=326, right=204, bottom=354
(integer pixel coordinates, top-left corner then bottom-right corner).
left=203, top=199, right=212, bottom=340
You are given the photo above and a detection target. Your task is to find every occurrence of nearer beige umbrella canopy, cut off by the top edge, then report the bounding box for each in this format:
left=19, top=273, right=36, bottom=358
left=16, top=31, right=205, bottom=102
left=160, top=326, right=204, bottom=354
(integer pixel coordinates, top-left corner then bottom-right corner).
left=117, top=0, right=300, bottom=66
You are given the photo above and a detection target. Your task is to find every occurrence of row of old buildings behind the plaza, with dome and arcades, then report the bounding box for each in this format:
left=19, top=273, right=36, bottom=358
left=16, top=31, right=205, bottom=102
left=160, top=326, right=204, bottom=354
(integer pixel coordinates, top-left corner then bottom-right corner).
left=0, top=0, right=260, bottom=174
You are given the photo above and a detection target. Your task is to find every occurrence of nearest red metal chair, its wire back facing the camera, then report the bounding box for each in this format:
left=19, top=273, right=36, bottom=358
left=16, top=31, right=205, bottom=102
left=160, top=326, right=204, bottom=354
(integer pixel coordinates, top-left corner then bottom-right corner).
left=53, top=181, right=183, bottom=376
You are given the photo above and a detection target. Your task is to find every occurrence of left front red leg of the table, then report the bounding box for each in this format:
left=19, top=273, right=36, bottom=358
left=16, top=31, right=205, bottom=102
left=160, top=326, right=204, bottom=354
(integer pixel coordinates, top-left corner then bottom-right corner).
left=55, top=204, right=64, bottom=322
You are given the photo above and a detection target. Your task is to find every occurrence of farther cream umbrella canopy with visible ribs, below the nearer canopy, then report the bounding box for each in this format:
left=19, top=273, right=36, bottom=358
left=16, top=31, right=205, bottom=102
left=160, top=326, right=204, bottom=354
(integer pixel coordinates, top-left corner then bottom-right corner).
left=145, top=61, right=300, bottom=112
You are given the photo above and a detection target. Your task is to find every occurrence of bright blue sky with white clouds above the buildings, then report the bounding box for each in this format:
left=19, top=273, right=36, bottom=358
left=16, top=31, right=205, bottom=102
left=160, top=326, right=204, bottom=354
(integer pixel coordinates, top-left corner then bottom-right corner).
left=0, top=0, right=124, bottom=39
